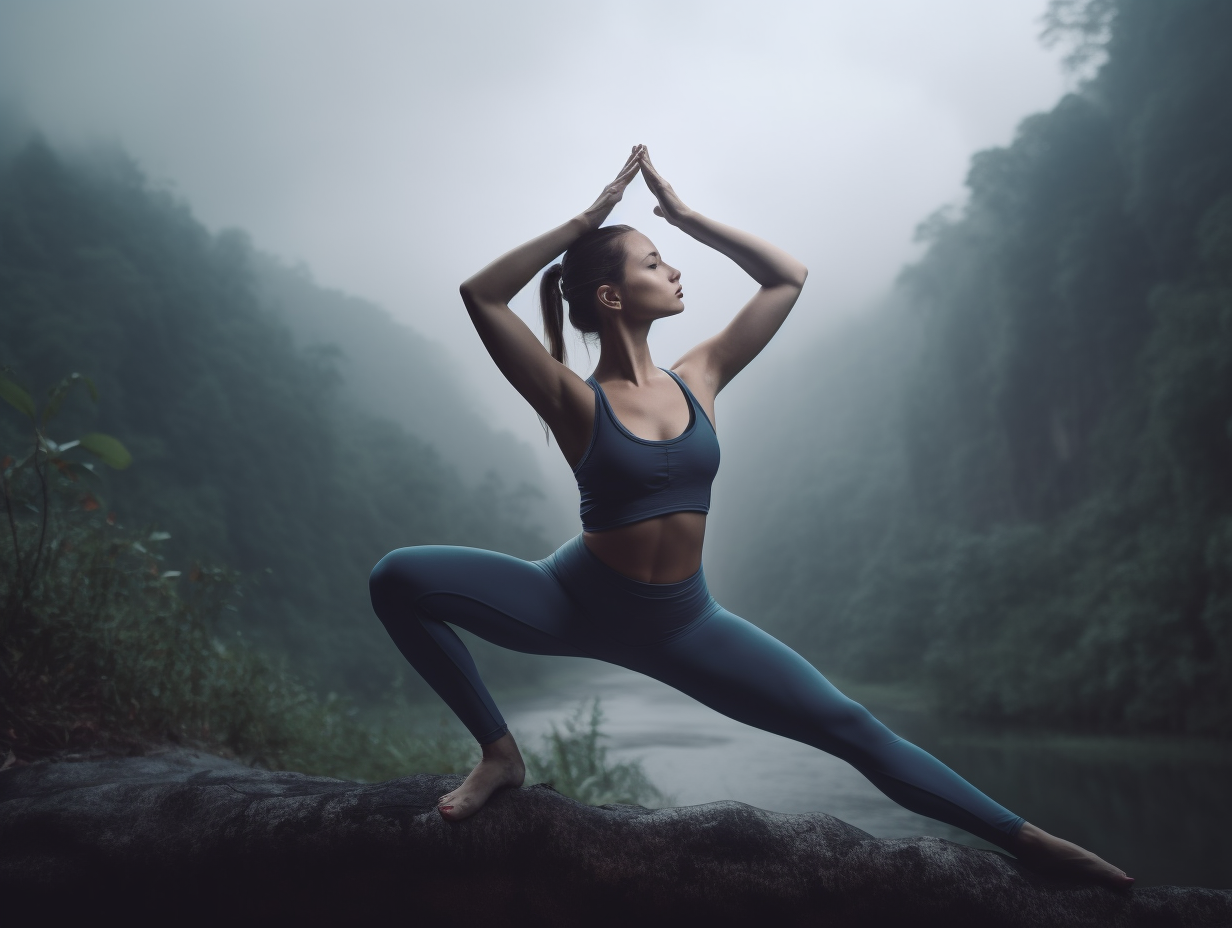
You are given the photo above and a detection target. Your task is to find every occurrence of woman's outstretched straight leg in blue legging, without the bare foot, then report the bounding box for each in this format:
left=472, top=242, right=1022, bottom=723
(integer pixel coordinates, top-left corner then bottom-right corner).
left=621, top=609, right=1023, bottom=849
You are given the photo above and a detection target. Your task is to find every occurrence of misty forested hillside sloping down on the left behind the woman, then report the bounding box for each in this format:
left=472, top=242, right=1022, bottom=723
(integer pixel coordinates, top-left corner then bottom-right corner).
left=0, top=133, right=547, bottom=691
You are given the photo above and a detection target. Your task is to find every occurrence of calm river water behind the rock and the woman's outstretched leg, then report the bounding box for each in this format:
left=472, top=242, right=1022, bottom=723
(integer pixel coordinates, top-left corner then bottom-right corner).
left=505, top=662, right=1232, bottom=889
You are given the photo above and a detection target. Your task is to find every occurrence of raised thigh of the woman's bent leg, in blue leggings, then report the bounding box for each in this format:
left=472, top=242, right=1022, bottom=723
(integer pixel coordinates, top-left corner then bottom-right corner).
left=371, top=545, right=590, bottom=657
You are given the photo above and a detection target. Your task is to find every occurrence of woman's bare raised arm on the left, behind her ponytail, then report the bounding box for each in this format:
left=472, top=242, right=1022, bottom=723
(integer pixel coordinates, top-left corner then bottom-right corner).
left=460, top=145, right=641, bottom=462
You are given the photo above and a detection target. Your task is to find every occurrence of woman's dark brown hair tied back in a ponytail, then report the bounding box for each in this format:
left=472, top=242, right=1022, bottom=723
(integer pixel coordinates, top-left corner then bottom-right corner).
left=540, top=226, right=633, bottom=364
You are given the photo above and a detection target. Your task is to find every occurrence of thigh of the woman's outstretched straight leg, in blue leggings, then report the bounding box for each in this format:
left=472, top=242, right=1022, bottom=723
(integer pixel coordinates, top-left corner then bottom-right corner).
left=628, top=609, right=898, bottom=763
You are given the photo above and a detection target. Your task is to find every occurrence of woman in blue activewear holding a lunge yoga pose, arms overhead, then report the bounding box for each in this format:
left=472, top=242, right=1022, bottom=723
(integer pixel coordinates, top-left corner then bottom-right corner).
left=370, top=145, right=1132, bottom=886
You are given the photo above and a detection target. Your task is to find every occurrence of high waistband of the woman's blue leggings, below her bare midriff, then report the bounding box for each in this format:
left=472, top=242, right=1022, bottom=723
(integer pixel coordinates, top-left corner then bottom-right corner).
left=538, top=535, right=719, bottom=645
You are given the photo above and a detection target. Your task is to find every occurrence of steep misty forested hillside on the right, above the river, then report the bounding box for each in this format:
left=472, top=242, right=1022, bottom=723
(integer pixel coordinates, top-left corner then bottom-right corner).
left=710, top=0, right=1232, bottom=736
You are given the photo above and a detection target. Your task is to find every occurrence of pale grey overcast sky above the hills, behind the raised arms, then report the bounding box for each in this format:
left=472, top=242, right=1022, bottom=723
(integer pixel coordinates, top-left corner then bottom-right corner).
left=0, top=0, right=1064, bottom=473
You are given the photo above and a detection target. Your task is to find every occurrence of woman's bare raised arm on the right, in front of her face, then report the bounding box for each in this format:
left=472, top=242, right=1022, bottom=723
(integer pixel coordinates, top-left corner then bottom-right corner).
left=642, top=150, right=808, bottom=397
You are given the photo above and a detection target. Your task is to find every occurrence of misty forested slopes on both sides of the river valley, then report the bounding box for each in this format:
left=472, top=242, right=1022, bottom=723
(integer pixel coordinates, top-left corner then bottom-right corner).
left=0, top=0, right=1232, bottom=769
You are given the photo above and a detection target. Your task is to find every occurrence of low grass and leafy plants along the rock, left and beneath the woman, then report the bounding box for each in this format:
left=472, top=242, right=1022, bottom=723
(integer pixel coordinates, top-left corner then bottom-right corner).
left=0, top=373, right=664, bottom=804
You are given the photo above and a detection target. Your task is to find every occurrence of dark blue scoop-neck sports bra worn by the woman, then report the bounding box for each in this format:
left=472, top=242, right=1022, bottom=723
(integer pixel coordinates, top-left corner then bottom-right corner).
left=573, top=368, right=718, bottom=531
